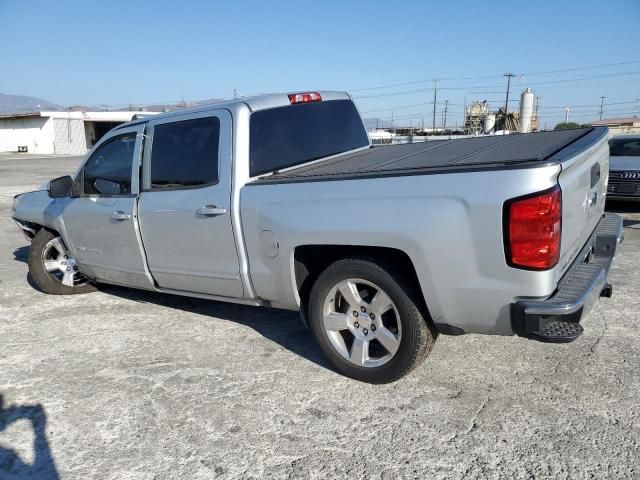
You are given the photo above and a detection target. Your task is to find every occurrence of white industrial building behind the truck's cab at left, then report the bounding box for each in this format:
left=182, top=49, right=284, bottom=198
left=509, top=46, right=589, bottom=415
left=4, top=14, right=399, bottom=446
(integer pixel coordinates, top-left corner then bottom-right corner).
left=0, top=112, right=158, bottom=155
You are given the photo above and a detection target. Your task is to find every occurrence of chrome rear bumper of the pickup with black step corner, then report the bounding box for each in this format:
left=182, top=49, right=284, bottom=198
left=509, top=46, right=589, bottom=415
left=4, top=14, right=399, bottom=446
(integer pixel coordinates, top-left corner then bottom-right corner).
left=511, top=213, right=623, bottom=343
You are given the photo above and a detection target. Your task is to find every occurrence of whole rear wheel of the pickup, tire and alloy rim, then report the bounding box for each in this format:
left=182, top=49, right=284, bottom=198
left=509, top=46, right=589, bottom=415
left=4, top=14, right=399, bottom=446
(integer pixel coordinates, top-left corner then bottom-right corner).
left=309, top=258, right=435, bottom=383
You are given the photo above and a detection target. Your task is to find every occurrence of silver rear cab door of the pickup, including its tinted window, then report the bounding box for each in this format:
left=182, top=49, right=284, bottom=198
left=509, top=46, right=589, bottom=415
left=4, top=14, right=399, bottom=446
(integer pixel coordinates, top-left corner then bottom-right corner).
left=139, top=110, right=243, bottom=297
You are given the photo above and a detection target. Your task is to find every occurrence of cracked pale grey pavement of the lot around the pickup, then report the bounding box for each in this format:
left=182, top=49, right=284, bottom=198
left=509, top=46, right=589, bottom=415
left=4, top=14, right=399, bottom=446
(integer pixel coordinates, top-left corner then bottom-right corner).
left=0, top=155, right=640, bottom=479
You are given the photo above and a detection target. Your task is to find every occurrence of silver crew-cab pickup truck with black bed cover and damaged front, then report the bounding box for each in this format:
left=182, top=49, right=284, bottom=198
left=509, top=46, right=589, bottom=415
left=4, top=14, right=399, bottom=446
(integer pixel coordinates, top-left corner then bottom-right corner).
left=12, top=91, right=622, bottom=383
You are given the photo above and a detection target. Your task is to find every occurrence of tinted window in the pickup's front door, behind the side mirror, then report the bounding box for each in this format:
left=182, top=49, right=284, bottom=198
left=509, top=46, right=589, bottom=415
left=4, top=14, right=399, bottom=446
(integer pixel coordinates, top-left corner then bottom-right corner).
left=82, top=133, right=136, bottom=196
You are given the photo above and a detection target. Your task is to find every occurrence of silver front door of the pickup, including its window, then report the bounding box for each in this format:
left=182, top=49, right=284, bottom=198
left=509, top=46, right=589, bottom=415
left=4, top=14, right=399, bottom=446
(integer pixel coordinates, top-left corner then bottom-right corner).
left=62, top=125, right=152, bottom=288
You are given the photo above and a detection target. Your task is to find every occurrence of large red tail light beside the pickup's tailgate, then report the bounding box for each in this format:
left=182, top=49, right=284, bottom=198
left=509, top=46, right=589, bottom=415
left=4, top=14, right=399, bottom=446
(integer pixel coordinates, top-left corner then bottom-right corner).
left=504, top=185, right=562, bottom=270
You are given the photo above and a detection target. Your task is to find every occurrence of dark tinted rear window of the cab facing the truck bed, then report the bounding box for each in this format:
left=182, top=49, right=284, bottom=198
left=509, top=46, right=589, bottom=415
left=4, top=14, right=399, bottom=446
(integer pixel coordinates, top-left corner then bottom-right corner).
left=249, top=100, right=369, bottom=176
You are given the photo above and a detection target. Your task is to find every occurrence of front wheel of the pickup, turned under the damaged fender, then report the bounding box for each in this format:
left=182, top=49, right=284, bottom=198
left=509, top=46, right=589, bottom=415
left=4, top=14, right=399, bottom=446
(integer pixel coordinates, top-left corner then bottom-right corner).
left=29, top=228, right=96, bottom=295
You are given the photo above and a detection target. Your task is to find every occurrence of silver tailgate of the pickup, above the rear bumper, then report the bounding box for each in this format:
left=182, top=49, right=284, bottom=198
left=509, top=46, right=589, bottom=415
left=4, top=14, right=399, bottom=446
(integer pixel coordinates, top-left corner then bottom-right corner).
left=549, top=129, right=609, bottom=279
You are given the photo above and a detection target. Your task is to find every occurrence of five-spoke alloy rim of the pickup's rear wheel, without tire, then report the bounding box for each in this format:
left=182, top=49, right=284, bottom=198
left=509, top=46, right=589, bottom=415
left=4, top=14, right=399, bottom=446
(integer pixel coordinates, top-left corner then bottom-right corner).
left=322, top=278, right=402, bottom=367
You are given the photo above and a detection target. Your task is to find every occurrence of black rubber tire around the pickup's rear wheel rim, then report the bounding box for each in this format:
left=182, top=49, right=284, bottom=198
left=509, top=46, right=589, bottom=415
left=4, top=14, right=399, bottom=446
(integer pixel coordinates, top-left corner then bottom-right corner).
left=309, top=258, right=436, bottom=384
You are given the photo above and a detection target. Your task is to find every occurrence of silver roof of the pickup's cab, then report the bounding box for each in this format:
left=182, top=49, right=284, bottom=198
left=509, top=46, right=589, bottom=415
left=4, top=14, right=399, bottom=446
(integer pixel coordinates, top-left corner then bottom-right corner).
left=116, top=90, right=351, bottom=129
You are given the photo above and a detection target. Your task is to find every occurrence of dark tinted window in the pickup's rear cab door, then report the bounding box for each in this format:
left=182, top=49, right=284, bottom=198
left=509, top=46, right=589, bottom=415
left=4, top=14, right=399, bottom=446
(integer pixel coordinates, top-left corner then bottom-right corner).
left=150, top=117, right=220, bottom=190
